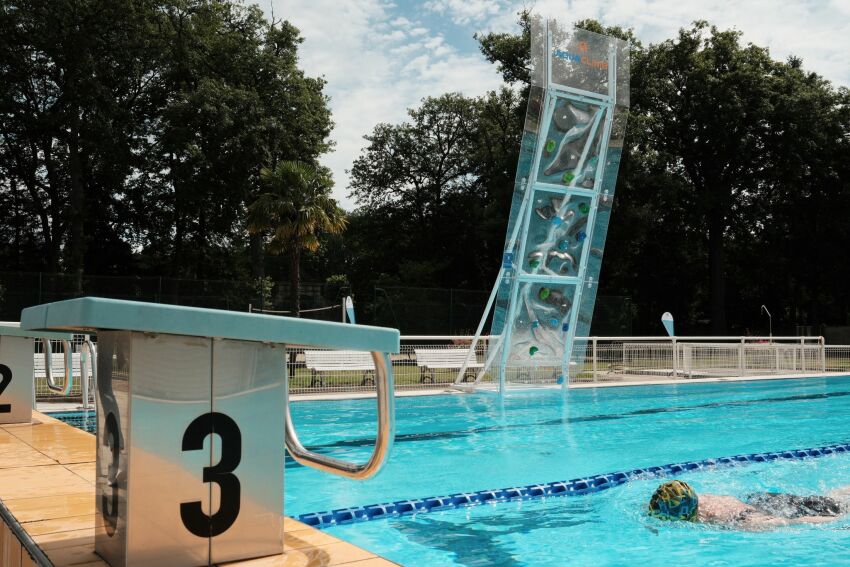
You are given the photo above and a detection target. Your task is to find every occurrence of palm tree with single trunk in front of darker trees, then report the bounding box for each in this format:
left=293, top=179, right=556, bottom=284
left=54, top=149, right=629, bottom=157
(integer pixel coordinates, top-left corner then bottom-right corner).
left=248, top=161, right=348, bottom=317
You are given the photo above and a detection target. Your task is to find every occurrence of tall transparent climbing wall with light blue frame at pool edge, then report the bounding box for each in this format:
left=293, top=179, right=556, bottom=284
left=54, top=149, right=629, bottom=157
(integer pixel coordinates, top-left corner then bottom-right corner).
left=457, top=18, right=629, bottom=390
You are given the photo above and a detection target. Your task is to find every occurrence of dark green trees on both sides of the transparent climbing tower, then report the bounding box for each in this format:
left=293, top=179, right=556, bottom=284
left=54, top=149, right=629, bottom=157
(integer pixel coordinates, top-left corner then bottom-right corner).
left=349, top=11, right=850, bottom=333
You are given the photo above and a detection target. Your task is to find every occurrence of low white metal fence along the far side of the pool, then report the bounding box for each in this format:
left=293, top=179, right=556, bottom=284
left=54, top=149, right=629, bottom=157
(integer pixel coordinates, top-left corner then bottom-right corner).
left=35, top=336, right=850, bottom=401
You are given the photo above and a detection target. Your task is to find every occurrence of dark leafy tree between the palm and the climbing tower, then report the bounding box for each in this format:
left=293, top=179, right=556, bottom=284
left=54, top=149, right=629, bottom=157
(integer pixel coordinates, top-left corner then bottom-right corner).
left=342, top=89, right=524, bottom=288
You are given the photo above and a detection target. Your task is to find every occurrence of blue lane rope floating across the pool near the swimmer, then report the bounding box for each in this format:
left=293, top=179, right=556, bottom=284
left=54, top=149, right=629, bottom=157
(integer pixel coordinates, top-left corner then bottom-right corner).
left=298, top=443, right=850, bottom=529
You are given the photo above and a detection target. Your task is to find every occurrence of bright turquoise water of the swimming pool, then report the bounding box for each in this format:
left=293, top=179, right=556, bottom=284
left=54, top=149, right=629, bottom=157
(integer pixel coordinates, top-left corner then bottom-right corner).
left=49, top=377, right=850, bottom=566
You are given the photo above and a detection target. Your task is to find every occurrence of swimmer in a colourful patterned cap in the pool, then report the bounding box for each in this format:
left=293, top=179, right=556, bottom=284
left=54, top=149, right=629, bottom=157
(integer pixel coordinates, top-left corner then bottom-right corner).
left=649, top=480, right=850, bottom=530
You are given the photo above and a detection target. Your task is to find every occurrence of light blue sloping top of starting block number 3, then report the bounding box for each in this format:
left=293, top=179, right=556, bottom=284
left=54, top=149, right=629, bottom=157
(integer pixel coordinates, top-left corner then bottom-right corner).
left=21, top=297, right=400, bottom=353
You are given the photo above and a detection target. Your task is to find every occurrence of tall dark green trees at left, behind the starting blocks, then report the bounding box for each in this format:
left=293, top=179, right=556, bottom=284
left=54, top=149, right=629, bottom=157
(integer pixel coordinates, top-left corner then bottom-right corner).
left=0, top=0, right=332, bottom=278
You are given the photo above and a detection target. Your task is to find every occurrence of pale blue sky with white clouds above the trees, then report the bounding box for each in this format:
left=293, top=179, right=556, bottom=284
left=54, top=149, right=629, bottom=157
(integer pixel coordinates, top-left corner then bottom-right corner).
left=268, top=0, right=850, bottom=210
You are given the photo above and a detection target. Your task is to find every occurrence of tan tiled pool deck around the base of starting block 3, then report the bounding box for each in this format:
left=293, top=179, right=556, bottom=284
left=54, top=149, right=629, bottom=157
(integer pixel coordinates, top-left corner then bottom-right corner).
left=0, top=411, right=396, bottom=567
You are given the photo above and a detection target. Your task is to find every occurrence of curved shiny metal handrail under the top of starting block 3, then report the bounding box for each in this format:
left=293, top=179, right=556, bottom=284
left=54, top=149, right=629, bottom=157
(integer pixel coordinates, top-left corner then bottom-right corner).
left=285, top=352, right=395, bottom=480
